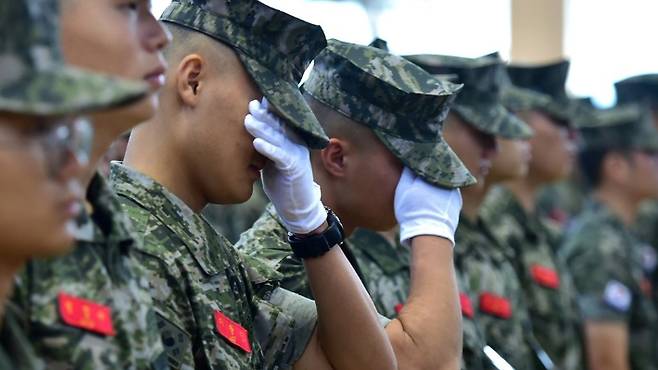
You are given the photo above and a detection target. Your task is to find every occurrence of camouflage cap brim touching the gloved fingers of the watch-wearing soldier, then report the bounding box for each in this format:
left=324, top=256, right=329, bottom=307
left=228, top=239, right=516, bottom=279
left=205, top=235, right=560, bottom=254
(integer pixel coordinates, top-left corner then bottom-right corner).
left=236, top=51, right=329, bottom=149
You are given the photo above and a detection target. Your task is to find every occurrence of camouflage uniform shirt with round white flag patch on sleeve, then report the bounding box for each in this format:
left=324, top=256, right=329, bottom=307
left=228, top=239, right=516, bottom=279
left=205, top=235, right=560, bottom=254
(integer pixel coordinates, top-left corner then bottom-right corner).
left=561, top=201, right=658, bottom=370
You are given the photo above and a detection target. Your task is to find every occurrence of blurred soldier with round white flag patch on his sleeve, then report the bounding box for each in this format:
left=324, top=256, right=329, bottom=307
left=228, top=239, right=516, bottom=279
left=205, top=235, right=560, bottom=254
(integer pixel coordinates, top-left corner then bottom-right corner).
left=561, top=105, right=658, bottom=369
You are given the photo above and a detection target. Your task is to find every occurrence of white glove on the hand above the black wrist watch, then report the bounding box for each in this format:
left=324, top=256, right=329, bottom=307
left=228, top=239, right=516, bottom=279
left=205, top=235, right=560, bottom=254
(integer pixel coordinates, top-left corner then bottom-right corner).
left=244, top=98, right=327, bottom=234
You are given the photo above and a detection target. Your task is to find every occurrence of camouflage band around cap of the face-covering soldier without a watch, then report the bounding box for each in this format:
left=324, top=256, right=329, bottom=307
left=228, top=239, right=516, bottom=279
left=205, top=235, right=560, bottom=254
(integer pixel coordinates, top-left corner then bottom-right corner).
left=302, top=69, right=455, bottom=143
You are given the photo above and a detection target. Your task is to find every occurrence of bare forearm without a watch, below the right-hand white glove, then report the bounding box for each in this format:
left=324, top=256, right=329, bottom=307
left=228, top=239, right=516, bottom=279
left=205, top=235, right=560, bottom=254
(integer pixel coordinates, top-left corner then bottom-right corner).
left=386, top=236, right=462, bottom=369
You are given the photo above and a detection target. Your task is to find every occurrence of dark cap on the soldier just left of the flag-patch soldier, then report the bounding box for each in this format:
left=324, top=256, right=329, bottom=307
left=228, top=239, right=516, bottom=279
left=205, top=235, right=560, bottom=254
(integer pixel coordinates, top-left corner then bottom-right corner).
left=507, top=60, right=573, bottom=125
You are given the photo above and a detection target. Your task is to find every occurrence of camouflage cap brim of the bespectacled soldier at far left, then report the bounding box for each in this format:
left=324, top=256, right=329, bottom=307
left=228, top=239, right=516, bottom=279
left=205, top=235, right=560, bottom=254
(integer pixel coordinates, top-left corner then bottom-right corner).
left=0, top=65, right=148, bottom=116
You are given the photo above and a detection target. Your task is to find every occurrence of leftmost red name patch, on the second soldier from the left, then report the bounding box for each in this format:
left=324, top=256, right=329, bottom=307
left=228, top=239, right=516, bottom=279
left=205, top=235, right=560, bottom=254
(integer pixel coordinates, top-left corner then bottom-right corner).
left=57, top=293, right=116, bottom=336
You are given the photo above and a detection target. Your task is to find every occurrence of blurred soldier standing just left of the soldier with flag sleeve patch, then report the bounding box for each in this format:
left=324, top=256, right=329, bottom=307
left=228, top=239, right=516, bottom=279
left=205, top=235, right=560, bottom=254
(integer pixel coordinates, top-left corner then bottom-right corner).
left=481, top=62, right=583, bottom=369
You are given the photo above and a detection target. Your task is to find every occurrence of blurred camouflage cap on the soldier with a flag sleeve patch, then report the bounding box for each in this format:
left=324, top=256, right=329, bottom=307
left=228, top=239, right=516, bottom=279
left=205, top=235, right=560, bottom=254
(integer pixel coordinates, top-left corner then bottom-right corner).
left=580, top=104, right=658, bottom=153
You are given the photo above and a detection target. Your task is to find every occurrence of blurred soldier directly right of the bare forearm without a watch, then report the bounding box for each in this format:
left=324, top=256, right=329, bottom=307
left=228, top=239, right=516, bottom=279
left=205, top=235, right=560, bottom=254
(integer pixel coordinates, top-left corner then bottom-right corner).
left=409, top=55, right=535, bottom=369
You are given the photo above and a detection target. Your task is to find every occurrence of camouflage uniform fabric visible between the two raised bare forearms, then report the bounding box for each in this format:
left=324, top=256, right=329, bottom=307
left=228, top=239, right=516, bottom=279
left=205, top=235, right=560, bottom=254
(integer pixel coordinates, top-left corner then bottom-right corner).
left=346, top=229, right=411, bottom=319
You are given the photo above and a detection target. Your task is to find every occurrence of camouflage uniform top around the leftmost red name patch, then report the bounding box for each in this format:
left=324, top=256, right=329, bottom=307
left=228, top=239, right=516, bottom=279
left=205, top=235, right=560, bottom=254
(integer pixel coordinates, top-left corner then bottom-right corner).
left=13, top=175, right=166, bottom=369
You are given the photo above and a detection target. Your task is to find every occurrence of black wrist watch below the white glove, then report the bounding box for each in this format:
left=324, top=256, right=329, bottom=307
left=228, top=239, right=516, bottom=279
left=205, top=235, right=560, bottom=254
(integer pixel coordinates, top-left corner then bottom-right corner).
left=288, top=207, right=345, bottom=259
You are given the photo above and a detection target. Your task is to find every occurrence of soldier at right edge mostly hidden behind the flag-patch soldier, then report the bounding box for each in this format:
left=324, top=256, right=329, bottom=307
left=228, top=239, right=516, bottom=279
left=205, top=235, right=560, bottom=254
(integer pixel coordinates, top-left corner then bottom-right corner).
left=615, top=74, right=658, bottom=305
